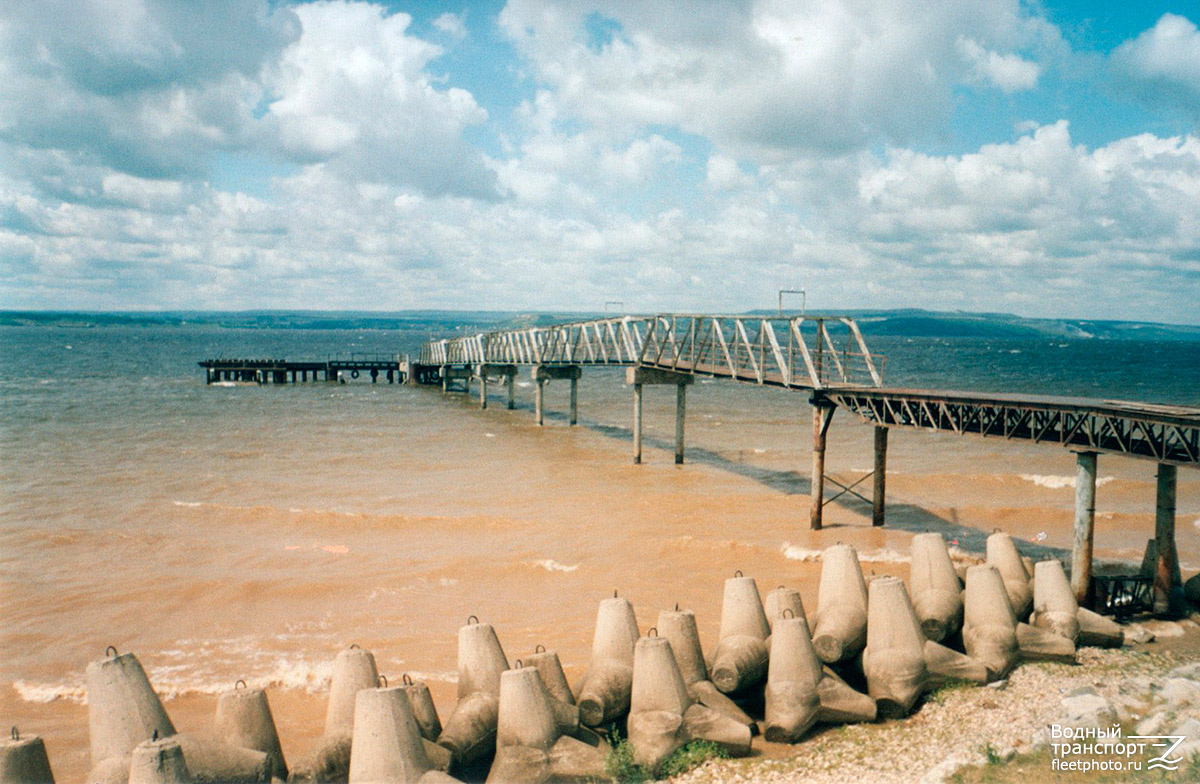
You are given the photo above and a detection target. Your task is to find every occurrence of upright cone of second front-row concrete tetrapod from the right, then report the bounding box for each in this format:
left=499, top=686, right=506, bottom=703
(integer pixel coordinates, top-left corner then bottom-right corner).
left=962, top=564, right=1018, bottom=680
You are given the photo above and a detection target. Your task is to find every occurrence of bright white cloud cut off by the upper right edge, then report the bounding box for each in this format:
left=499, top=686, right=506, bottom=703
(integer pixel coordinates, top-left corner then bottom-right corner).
left=1111, top=13, right=1200, bottom=118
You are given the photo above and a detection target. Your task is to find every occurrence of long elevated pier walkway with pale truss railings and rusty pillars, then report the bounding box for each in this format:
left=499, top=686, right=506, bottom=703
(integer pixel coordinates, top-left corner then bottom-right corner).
left=408, top=315, right=1200, bottom=612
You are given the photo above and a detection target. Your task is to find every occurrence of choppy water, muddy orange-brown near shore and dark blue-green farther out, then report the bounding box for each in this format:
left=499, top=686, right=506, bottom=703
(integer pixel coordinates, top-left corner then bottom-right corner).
left=0, top=327, right=1200, bottom=780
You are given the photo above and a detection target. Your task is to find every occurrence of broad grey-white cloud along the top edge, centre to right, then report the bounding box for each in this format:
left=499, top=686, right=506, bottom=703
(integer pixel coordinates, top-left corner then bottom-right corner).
left=500, top=0, right=1058, bottom=161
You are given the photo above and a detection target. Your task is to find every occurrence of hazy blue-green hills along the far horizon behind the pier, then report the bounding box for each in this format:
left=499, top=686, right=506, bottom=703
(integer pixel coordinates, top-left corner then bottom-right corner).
left=0, top=309, right=1200, bottom=341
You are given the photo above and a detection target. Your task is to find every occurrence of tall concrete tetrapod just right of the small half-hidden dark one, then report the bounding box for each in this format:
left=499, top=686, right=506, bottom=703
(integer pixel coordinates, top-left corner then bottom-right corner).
left=438, top=620, right=509, bottom=770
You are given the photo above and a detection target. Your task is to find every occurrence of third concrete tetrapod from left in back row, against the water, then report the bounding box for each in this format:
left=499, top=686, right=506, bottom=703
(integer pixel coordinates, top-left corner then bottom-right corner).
left=292, top=645, right=379, bottom=783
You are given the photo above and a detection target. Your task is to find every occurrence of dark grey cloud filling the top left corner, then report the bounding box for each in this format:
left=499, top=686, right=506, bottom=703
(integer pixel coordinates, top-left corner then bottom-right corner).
left=0, top=0, right=300, bottom=176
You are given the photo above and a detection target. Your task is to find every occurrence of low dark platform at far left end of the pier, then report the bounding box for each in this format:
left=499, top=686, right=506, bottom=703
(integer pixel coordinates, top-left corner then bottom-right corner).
left=198, top=354, right=408, bottom=384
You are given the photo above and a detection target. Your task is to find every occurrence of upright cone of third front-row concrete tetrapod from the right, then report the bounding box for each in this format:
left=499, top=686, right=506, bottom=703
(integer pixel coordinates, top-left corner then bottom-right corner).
left=863, top=577, right=929, bottom=718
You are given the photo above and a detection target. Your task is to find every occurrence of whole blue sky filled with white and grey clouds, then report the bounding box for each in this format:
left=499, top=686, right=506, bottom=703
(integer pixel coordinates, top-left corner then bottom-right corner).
left=0, top=0, right=1200, bottom=324
